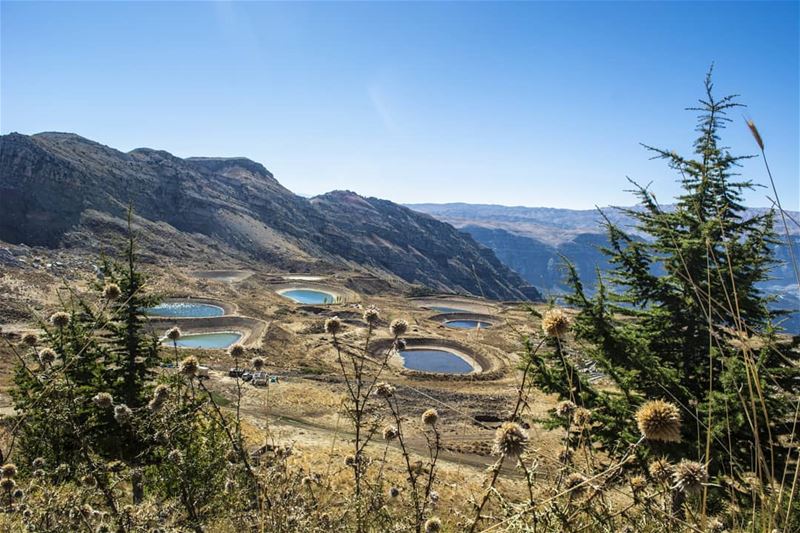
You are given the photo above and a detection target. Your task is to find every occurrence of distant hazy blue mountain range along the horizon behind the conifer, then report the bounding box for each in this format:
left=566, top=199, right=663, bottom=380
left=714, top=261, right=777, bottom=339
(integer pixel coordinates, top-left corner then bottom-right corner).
left=408, top=203, right=800, bottom=332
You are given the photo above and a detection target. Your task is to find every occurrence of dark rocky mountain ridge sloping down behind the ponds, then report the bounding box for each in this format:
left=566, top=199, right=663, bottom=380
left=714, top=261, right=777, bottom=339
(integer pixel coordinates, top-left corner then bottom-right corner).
left=0, top=133, right=538, bottom=299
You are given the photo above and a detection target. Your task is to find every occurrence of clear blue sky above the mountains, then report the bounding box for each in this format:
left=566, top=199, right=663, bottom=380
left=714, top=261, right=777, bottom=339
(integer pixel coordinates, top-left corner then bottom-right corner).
left=0, top=1, right=800, bottom=209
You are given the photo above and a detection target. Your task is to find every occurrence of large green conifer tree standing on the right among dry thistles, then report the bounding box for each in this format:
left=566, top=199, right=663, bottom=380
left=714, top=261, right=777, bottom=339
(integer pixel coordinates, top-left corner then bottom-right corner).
left=552, top=68, right=798, bottom=477
